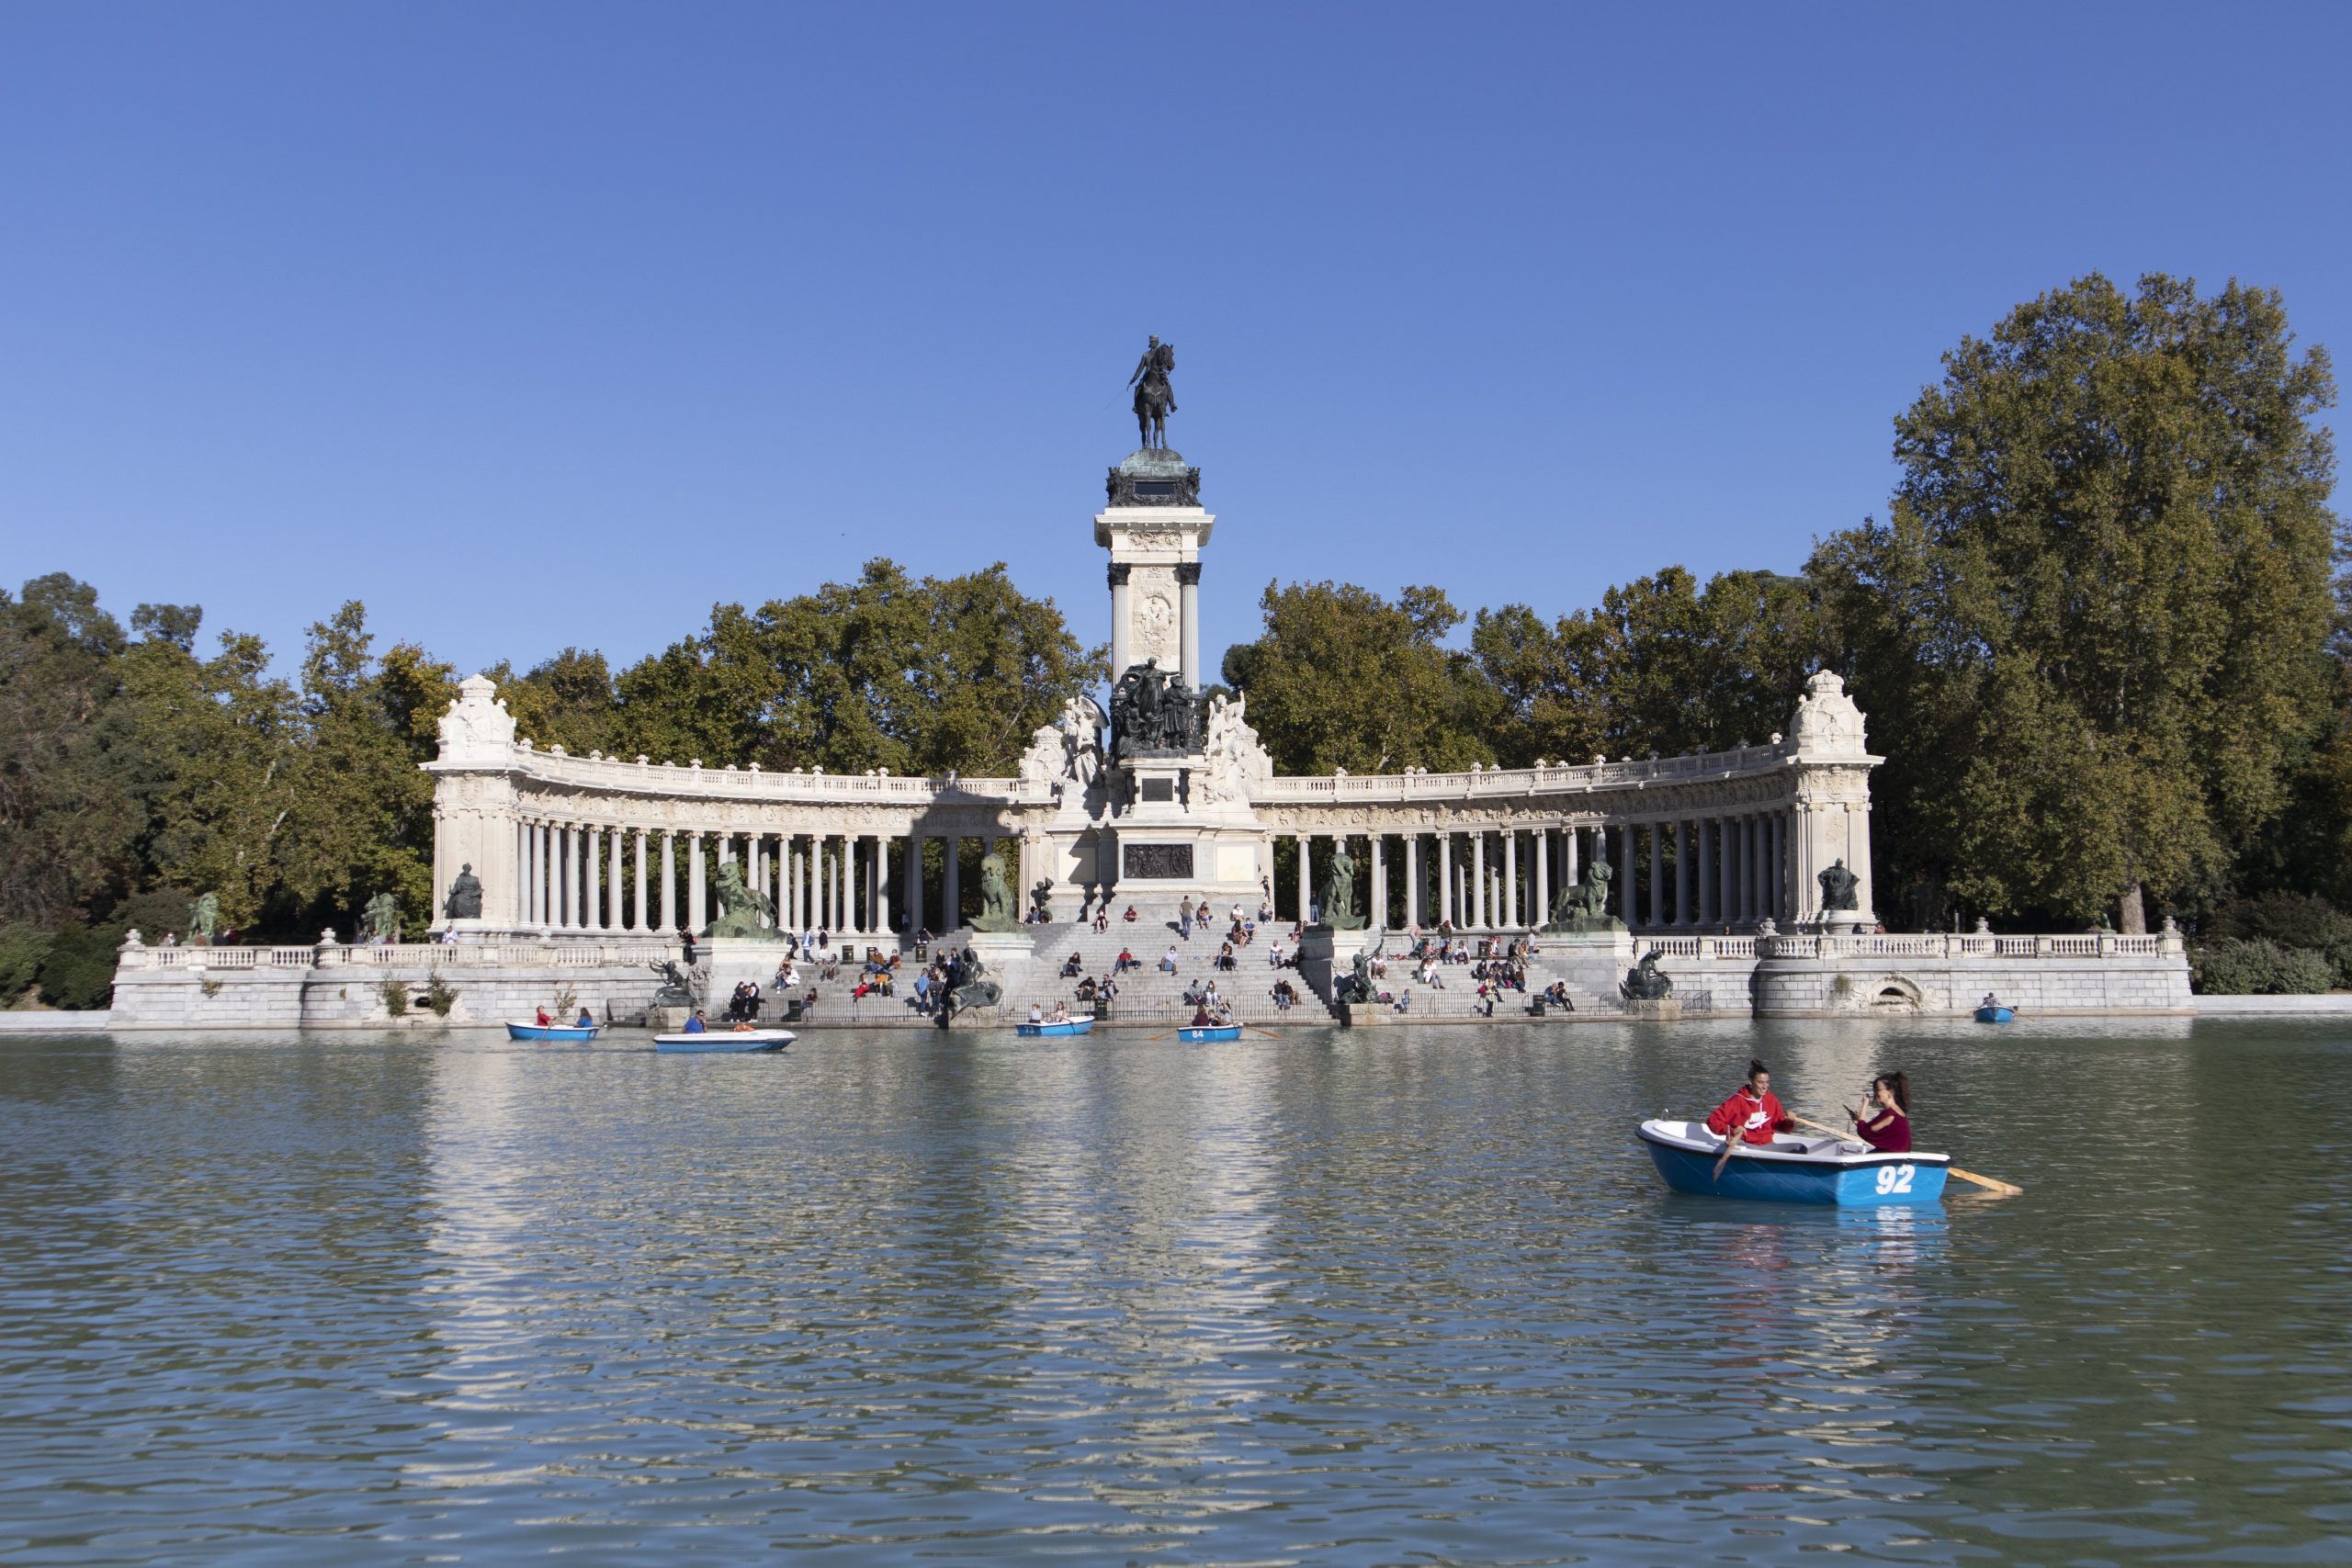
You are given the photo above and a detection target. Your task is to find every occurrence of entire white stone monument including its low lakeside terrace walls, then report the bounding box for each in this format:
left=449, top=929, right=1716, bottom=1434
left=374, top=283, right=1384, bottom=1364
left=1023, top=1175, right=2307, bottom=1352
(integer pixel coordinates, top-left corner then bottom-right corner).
left=115, top=339, right=2189, bottom=1027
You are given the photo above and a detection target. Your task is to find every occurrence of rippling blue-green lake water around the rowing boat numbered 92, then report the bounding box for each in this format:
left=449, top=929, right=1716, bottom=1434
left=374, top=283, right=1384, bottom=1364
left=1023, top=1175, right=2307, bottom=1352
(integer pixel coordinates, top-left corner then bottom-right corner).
left=0, top=1021, right=2352, bottom=1565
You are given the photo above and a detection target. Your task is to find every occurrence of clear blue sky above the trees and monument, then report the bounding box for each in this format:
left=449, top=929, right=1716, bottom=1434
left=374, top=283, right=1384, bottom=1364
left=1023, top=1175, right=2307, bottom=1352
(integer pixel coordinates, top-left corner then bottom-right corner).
left=0, top=0, right=2352, bottom=686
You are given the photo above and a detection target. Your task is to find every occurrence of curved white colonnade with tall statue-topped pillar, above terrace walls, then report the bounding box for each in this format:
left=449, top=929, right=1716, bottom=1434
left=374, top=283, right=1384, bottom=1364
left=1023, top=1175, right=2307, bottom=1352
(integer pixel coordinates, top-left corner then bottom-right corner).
left=428, top=339, right=1877, bottom=959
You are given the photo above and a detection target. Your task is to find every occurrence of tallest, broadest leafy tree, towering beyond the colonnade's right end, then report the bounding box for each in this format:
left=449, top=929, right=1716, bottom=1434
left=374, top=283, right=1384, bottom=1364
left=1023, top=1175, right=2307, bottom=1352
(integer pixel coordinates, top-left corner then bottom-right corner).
left=1809, top=275, right=2338, bottom=931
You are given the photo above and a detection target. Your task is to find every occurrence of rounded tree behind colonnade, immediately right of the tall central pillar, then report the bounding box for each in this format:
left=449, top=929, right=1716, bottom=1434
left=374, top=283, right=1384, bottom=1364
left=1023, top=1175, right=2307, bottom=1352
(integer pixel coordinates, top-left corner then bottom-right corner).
left=1223, top=583, right=1498, bottom=773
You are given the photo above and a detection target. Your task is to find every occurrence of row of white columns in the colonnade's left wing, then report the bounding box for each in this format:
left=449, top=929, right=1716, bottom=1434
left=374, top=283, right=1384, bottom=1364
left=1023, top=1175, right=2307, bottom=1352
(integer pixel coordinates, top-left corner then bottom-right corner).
left=513, top=820, right=1030, bottom=936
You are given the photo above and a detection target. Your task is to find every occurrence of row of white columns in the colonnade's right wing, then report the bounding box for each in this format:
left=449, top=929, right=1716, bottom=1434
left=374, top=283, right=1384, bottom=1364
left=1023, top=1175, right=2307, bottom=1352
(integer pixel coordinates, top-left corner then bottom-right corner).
left=1294, top=808, right=1797, bottom=931
